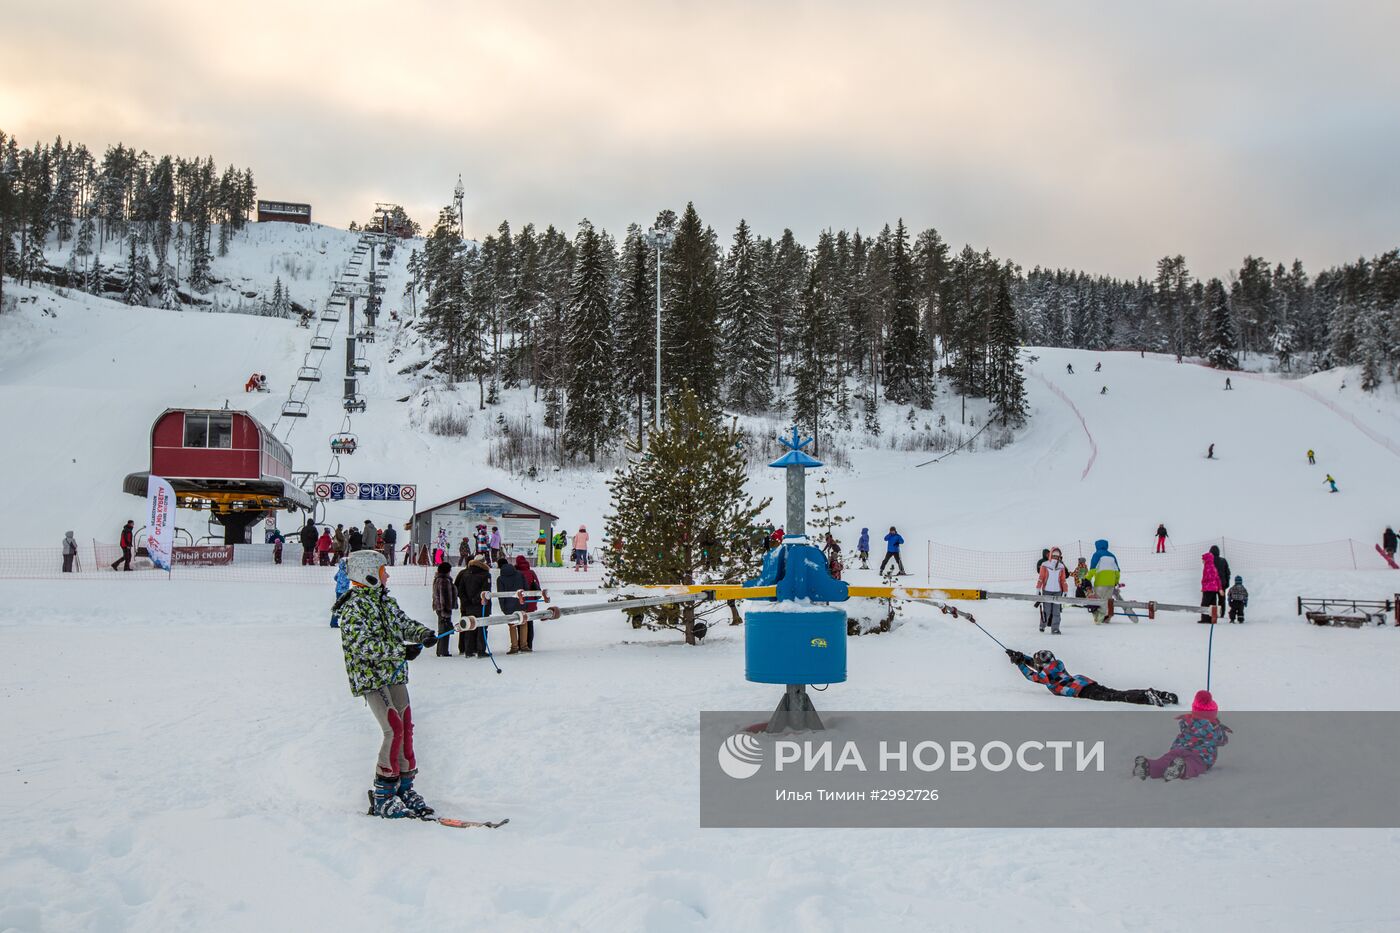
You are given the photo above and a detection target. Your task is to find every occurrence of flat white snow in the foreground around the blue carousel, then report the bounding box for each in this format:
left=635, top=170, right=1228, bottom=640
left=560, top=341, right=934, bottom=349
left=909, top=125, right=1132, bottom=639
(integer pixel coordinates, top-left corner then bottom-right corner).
left=0, top=573, right=1400, bottom=932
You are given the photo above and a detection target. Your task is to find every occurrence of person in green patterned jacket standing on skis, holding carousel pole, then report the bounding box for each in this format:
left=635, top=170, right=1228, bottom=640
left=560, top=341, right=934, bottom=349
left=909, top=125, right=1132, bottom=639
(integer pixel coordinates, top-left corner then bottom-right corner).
left=336, top=551, right=437, bottom=818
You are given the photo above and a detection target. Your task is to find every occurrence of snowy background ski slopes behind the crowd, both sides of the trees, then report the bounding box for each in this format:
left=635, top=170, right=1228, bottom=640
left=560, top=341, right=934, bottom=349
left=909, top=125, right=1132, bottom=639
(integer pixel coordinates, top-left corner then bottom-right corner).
left=10, top=232, right=1400, bottom=563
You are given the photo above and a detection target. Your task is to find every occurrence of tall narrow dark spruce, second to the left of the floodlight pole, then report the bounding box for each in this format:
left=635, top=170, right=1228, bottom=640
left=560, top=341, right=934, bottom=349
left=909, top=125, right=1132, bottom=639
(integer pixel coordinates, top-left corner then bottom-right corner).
left=564, top=220, right=615, bottom=464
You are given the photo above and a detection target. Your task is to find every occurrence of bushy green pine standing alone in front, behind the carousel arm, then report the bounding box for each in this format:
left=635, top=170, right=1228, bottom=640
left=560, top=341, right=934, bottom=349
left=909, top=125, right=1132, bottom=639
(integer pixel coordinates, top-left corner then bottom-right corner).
left=606, top=384, right=770, bottom=644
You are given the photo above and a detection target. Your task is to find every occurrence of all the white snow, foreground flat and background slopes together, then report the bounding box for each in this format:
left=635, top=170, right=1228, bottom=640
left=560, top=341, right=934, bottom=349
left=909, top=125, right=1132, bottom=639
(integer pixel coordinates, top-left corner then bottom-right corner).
left=0, top=227, right=1400, bottom=932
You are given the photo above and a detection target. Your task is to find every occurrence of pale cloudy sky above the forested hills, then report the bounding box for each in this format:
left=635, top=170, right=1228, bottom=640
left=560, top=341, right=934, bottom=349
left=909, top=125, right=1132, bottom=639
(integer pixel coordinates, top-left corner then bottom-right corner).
left=0, top=0, right=1400, bottom=276
